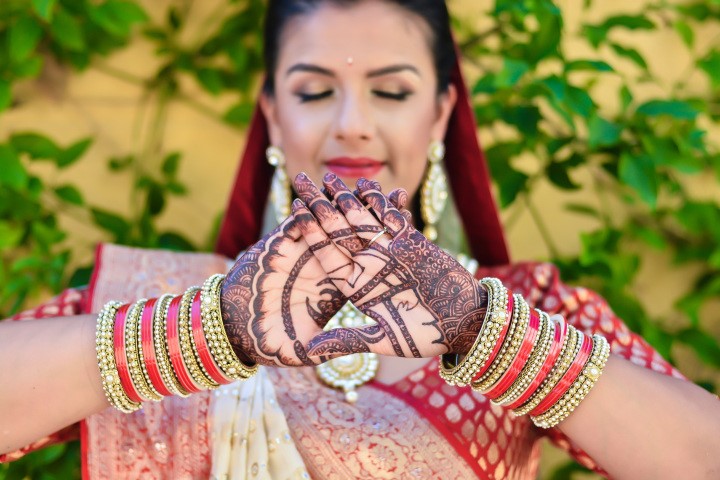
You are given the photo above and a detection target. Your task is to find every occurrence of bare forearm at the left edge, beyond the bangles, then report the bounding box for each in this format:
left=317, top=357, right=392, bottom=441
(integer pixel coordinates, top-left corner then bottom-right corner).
left=0, top=315, right=108, bottom=453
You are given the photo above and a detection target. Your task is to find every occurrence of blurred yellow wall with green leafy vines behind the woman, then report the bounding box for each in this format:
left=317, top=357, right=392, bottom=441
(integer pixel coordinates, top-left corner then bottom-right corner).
left=0, top=0, right=720, bottom=479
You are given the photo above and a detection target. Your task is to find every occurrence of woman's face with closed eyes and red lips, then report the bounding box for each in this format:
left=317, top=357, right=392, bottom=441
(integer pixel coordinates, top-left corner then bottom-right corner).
left=262, top=1, right=455, bottom=201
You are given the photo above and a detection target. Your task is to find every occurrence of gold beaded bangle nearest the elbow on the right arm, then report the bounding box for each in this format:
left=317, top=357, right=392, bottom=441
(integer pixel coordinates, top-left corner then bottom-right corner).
left=530, top=335, right=610, bottom=428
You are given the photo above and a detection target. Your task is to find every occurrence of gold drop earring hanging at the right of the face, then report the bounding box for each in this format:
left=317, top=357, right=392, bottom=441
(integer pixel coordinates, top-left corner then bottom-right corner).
left=420, top=140, right=448, bottom=241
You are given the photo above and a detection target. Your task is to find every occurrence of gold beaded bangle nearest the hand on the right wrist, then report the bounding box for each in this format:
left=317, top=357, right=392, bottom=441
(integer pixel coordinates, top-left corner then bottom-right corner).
left=440, top=277, right=510, bottom=386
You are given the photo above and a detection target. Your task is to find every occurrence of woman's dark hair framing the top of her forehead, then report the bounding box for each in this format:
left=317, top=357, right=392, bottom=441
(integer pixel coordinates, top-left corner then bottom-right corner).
left=263, top=0, right=455, bottom=95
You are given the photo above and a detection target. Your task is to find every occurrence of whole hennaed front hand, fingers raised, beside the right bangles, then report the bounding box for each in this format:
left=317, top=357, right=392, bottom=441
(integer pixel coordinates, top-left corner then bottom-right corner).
left=293, top=174, right=487, bottom=358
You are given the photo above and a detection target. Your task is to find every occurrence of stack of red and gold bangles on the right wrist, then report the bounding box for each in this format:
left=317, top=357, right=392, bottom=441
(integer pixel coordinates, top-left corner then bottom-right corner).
left=440, top=278, right=610, bottom=428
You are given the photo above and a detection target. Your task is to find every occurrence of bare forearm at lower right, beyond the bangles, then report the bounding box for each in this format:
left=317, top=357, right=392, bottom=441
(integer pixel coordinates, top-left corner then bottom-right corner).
left=559, top=356, right=720, bottom=479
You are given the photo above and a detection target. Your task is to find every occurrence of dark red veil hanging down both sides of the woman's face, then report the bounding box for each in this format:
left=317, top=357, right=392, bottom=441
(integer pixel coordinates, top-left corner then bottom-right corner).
left=215, top=62, right=509, bottom=266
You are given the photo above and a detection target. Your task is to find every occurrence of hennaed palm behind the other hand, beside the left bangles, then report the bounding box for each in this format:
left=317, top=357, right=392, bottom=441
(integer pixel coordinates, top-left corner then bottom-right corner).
left=221, top=217, right=347, bottom=366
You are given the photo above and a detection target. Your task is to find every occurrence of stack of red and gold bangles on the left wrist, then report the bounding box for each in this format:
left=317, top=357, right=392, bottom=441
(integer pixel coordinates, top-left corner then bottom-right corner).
left=96, top=275, right=258, bottom=413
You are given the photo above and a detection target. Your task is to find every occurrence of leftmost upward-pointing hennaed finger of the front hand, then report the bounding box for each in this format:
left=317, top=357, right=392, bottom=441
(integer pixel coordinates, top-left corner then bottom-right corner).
left=295, top=173, right=363, bottom=256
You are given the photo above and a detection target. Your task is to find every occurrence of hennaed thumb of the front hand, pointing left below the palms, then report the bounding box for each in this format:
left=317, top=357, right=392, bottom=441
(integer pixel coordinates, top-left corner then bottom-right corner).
left=300, top=325, right=396, bottom=362
